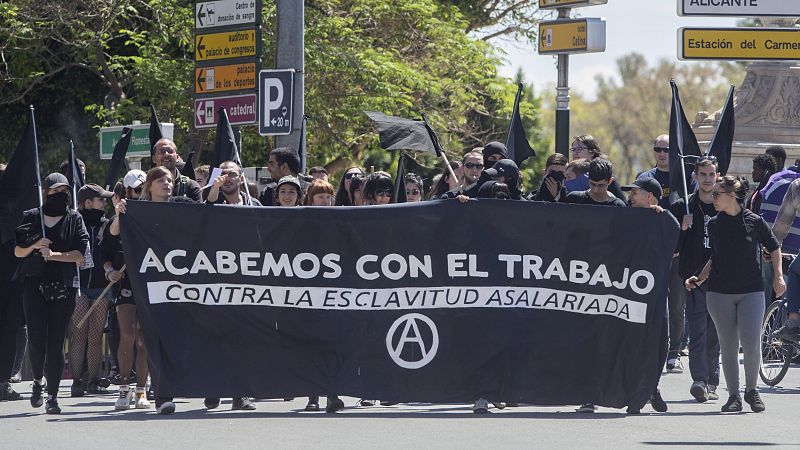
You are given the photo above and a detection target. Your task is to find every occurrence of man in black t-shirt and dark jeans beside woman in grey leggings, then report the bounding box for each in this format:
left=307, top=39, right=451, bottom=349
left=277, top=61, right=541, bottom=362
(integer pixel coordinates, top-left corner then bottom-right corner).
left=669, top=159, right=719, bottom=403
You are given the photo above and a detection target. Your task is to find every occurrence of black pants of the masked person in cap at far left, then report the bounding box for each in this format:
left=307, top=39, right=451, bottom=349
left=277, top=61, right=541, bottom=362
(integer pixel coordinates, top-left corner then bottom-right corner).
left=22, top=278, right=77, bottom=395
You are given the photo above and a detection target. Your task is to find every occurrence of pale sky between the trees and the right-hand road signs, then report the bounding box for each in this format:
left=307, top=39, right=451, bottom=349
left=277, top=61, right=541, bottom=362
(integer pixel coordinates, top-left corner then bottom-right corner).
left=495, top=0, right=736, bottom=99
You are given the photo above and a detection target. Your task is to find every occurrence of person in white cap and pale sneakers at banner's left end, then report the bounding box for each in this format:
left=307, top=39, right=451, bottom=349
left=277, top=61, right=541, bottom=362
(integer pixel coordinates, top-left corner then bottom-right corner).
left=103, top=169, right=151, bottom=411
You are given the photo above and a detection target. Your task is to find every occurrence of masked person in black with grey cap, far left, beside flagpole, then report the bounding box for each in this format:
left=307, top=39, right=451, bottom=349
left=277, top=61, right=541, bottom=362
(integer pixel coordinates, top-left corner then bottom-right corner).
left=14, top=173, right=89, bottom=414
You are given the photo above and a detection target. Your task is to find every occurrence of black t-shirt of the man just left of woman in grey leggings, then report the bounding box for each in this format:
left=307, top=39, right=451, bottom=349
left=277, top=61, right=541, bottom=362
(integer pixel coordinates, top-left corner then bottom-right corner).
left=670, top=193, right=717, bottom=280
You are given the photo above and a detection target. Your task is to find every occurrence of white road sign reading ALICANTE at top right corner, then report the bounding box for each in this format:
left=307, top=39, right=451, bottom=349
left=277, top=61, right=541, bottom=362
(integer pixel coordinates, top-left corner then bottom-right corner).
left=678, top=0, right=800, bottom=17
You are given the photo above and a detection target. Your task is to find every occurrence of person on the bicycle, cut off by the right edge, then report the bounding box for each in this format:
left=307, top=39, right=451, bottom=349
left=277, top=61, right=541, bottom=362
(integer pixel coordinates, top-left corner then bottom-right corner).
left=772, top=179, right=800, bottom=342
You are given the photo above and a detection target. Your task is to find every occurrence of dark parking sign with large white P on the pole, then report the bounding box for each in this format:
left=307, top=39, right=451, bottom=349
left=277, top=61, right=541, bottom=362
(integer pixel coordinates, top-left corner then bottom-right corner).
left=258, top=69, right=294, bottom=136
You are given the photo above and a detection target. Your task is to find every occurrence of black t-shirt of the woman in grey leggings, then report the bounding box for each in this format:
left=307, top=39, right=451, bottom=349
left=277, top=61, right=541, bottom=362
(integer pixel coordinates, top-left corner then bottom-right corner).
left=708, top=209, right=779, bottom=294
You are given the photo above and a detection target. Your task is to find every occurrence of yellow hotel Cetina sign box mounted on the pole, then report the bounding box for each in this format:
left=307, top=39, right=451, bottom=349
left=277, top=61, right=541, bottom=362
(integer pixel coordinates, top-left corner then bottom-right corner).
left=539, top=18, right=606, bottom=55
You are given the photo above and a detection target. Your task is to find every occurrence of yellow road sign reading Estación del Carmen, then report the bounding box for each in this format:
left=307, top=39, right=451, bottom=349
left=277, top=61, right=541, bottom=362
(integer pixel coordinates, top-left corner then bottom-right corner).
left=678, top=28, right=800, bottom=61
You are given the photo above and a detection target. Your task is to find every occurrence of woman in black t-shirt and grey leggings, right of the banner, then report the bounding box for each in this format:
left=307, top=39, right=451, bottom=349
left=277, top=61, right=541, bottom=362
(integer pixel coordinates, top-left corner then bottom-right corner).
left=685, top=175, right=786, bottom=412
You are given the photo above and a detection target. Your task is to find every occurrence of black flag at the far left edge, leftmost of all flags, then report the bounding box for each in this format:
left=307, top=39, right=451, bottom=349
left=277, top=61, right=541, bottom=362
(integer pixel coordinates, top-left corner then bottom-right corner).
left=0, top=108, right=41, bottom=243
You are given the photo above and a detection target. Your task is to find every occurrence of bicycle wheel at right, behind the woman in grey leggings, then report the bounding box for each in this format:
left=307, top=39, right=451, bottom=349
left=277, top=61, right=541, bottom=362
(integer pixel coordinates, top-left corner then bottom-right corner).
left=758, top=300, right=794, bottom=386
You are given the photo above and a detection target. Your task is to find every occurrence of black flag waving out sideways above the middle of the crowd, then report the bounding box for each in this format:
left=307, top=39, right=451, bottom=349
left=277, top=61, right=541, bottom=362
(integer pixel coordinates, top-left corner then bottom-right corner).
left=365, top=111, right=440, bottom=156
